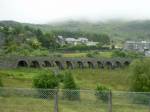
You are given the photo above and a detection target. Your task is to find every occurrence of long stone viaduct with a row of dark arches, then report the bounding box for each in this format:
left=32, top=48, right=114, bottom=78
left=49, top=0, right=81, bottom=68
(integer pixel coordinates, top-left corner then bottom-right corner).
left=0, top=57, right=132, bottom=69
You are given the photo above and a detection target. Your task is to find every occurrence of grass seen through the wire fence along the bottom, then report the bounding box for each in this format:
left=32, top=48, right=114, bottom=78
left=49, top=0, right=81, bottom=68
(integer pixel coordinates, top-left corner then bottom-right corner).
left=0, top=91, right=149, bottom=112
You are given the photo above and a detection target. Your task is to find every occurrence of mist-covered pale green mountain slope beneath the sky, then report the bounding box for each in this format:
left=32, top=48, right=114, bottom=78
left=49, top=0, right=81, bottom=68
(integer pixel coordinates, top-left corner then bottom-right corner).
left=0, top=20, right=150, bottom=40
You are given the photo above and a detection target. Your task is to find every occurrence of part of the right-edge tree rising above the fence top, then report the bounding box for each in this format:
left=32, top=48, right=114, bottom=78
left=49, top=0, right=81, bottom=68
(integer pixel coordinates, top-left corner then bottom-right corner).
left=131, top=59, right=150, bottom=92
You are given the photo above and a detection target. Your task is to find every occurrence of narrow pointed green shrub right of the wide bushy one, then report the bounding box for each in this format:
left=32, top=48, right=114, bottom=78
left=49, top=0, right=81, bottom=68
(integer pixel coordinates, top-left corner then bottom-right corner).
left=63, top=72, right=80, bottom=100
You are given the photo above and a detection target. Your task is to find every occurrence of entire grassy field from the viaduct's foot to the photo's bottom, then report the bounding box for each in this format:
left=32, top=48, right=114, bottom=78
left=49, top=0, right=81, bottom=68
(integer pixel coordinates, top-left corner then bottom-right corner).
left=0, top=68, right=149, bottom=112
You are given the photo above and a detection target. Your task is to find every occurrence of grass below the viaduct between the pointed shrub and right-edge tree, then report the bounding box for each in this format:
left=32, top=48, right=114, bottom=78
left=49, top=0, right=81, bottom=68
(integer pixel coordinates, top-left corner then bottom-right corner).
left=71, top=69, right=130, bottom=91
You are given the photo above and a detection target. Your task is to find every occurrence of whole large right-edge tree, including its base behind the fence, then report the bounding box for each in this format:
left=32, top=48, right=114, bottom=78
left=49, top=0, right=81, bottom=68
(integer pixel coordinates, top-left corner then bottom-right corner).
left=130, top=59, right=150, bottom=104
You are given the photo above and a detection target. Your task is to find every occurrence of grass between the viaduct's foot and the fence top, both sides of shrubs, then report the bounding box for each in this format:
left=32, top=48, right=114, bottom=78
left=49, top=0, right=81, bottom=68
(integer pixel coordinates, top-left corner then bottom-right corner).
left=0, top=68, right=130, bottom=90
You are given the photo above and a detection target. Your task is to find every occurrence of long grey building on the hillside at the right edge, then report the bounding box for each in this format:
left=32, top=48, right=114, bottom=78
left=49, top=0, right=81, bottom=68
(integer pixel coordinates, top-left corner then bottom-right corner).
left=124, top=41, right=150, bottom=52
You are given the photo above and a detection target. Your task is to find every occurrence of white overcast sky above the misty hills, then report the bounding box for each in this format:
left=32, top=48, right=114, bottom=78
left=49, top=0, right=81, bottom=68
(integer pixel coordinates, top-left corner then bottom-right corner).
left=0, top=0, right=150, bottom=23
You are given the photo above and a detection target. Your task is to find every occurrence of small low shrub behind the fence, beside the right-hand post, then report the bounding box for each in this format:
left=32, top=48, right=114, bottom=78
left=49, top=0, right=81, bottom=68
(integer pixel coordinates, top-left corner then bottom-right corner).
left=95, top=84, right=110, bottom=102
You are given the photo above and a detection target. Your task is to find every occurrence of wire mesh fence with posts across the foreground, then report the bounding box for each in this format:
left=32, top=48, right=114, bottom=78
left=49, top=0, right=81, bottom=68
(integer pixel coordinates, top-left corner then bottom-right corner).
left=0, top=88, right=150, bottom=112
